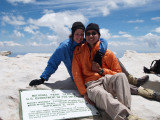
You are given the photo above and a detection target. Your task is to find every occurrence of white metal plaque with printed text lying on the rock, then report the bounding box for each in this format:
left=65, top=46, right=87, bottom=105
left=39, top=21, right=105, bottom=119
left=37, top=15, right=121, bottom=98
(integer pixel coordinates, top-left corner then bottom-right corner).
left=20, top=90, right=99, bottom=120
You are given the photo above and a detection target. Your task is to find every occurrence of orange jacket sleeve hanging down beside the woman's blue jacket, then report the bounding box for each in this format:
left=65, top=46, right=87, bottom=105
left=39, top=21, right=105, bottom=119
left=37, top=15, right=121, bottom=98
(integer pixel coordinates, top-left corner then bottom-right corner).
left=72, top=49, right=86, bottom=95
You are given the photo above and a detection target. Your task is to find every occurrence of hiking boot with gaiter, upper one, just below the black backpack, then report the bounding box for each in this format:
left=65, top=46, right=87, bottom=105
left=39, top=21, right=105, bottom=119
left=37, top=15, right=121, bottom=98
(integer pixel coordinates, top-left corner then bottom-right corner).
left=127, top=74, right=149, bottom=87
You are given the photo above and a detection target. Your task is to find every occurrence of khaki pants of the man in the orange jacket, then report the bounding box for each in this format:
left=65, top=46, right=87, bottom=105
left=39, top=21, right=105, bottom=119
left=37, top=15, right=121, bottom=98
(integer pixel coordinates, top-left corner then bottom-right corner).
left=86, top=73, right=131, bottom=120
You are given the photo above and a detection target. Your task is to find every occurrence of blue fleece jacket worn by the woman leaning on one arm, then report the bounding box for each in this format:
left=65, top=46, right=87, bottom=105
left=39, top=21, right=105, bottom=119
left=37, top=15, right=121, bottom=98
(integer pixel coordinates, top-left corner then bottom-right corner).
left=40, top=38, right=108, bottom=80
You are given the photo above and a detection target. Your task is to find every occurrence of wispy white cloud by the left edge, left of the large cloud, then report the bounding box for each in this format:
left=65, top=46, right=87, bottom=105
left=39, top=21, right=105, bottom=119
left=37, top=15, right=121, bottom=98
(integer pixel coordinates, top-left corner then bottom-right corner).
left=2, top=15, right=25, bottom=26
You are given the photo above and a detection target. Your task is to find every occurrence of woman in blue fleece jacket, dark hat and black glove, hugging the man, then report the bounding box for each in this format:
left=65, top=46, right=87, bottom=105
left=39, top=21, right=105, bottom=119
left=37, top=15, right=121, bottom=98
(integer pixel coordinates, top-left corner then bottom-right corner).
left=29, top=22, right=108, bottom=86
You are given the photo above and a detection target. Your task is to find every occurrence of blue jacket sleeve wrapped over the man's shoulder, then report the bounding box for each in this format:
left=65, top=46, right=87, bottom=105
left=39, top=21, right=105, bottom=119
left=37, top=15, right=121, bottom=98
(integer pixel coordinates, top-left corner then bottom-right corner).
left=99, top=38, right=108, bottom=54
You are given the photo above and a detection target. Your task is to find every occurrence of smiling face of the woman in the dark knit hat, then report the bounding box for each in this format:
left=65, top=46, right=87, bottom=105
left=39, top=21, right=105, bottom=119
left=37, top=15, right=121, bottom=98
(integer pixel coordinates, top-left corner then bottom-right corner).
left=73, top=29, right=84, bottom=43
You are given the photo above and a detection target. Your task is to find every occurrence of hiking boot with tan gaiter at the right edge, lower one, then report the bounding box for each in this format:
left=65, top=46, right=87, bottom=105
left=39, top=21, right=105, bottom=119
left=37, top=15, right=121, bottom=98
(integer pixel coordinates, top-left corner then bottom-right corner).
left=138, top=87, right=160, bottom=101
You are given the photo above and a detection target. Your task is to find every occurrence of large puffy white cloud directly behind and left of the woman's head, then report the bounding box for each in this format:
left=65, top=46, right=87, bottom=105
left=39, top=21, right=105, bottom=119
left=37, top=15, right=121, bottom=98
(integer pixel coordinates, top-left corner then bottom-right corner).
left=28, top=12, right=88, bottom=42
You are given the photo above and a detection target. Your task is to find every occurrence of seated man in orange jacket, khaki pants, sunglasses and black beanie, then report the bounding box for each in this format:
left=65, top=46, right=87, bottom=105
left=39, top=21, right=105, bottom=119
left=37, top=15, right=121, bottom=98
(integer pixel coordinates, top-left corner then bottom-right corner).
left=72, top=23, right=142, bottom=120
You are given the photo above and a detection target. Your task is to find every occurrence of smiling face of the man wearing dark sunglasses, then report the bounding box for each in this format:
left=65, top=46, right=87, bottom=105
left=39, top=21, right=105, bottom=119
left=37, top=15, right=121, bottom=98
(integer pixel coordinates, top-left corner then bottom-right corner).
left=86, top=30, right=99, bottom=47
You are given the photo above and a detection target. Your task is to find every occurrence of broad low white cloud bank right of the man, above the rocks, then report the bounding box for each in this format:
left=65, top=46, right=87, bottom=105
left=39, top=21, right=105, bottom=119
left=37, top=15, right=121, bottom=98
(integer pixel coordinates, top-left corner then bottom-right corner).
left=109, top=31, right=160, bottom=50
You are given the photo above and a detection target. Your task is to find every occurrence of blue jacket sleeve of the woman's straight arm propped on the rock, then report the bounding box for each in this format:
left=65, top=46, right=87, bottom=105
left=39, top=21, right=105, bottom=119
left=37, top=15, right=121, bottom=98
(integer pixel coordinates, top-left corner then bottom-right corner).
left=40, top=45, right=64, bottom=80
